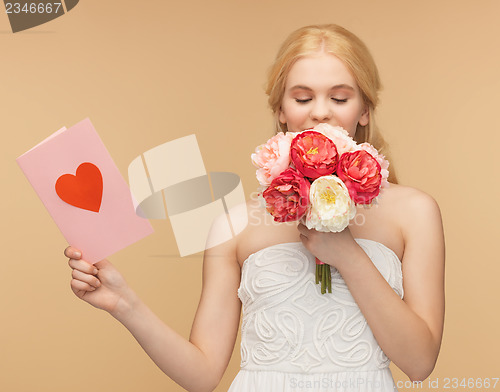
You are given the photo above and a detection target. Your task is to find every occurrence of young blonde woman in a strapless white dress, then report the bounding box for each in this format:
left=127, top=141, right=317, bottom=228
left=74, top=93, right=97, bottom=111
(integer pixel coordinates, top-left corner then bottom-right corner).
left=65, top=25, right=444, bottom=392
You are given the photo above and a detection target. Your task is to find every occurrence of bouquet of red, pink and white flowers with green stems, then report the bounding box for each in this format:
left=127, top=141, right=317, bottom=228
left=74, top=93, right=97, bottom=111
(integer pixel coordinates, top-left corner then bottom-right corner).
left=252, top=124, right=389, bottom=294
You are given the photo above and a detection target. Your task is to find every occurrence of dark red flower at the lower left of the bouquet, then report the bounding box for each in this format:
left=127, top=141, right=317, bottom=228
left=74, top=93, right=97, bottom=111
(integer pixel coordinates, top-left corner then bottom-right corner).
left=262, top=168, right=310, bottom=222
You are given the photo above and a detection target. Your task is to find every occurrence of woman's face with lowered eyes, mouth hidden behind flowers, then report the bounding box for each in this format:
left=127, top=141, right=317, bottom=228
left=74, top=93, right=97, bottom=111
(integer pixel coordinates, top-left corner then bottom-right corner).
left=279, top=52, right=369, bottom=137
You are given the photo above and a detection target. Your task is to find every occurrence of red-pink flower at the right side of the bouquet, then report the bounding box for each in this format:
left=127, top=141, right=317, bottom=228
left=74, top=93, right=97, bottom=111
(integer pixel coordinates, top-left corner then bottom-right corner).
left=337, top=150, right=382, bottom=204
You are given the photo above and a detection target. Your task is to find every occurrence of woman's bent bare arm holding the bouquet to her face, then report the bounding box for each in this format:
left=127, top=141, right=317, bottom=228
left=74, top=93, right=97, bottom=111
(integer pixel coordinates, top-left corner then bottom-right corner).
left=300, top=192, right=445, bottom=381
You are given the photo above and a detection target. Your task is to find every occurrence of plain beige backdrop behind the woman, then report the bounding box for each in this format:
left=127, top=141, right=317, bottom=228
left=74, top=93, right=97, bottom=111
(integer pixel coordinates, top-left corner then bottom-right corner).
left=0, top=0, right=500, bottom=392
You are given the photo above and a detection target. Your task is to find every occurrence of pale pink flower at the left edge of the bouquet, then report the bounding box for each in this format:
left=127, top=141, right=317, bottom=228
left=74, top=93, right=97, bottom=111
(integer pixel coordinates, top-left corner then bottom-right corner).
left=252, top=132, right=294, bottom=186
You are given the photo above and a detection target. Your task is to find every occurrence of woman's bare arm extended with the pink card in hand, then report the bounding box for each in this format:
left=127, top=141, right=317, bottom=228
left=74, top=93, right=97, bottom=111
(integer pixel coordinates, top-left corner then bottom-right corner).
left=66, top=214, right=241, bottom=391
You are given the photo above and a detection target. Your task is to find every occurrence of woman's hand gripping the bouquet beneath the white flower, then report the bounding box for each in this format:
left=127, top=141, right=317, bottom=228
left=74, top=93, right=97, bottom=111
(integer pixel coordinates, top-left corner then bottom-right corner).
left=297, top=223, right=363, bottom=269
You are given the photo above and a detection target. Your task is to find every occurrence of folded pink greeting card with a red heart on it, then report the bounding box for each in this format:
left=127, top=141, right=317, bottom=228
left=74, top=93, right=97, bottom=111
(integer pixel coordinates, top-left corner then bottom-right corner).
left=16, top=119, right=153, bottom=263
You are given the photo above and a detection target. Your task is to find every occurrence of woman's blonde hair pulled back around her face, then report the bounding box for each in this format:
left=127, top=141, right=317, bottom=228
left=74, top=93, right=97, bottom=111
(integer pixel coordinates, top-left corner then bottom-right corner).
left=266, top=24, right=398, bottom=184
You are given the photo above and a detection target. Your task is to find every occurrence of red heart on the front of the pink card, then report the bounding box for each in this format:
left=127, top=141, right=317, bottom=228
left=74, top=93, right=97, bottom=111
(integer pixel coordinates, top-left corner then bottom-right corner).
left=56, top=162, right=102, bottom=212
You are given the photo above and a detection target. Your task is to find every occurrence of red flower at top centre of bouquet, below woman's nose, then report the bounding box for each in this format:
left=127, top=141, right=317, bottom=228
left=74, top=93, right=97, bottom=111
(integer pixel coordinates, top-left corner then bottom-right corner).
left=290, top=131, right=338, bottom=180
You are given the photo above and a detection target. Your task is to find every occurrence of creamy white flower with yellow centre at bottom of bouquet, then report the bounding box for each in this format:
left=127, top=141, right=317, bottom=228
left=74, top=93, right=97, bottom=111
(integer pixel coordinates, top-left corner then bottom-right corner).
left=305, top=175, right=356, bottom=232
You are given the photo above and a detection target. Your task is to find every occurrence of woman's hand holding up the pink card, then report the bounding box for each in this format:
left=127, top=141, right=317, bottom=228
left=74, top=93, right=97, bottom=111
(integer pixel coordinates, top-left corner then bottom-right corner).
left=64, top=246, right=132, bottom=315
